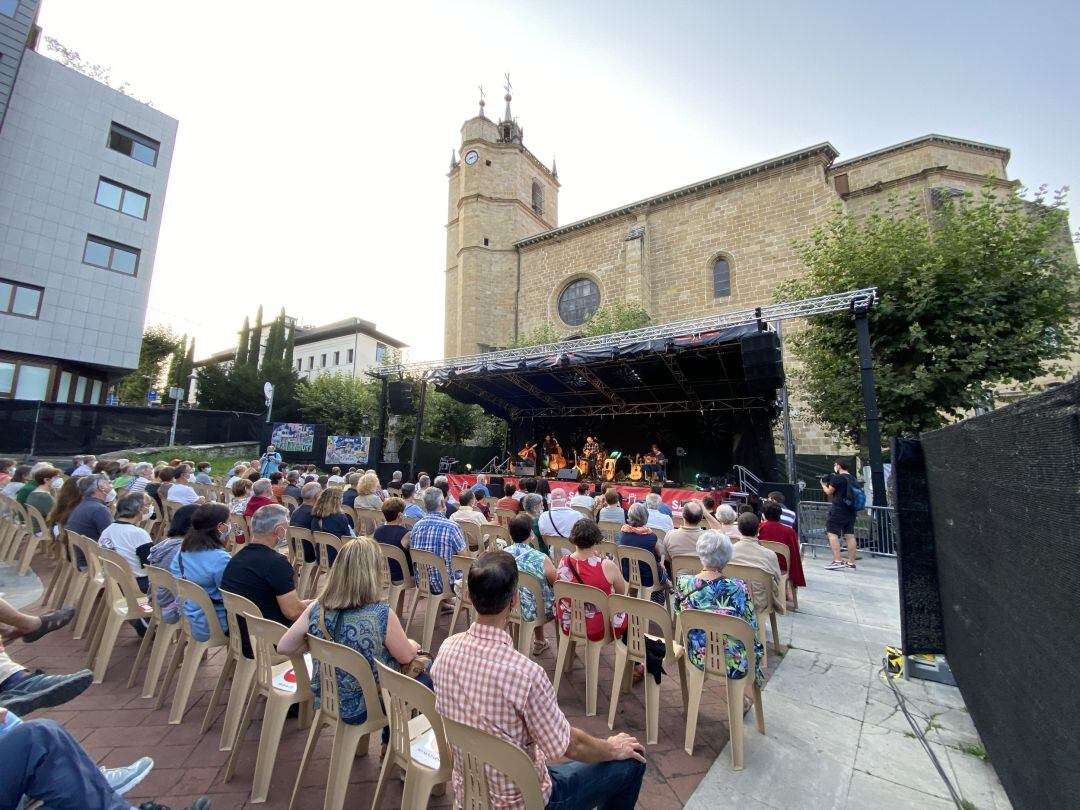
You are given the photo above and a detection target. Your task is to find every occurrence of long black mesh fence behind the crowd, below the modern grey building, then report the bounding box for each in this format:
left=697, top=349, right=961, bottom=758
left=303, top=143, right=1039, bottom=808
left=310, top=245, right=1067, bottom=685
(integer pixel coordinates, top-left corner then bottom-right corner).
left=0, top=400, right=264, bottom=456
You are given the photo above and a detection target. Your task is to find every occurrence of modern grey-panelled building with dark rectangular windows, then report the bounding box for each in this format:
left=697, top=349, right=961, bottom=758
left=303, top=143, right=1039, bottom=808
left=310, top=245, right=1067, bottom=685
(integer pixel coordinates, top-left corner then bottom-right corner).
left=0, top=0, right=177, bottom=403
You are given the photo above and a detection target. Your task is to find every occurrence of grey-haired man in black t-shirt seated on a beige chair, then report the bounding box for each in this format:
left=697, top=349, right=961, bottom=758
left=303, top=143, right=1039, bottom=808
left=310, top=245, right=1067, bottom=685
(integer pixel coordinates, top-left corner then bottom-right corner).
left=221, top=503, right=308, bottom=658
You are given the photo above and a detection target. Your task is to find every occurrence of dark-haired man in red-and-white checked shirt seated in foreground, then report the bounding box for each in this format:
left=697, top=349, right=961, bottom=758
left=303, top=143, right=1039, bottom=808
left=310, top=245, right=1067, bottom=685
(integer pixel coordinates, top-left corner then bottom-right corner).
left=431, top=551, right=645, bottom=810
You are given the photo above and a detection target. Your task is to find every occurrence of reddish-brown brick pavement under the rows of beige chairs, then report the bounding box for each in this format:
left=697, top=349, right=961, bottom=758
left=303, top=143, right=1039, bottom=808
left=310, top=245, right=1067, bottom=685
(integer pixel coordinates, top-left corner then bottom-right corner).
left=10, top=557, right=779, bottom=810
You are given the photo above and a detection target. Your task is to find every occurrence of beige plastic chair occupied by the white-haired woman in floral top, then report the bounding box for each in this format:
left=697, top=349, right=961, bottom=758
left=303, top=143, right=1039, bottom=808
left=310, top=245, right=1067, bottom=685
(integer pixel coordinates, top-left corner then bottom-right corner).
left=676, top=610, right=765, bottom=771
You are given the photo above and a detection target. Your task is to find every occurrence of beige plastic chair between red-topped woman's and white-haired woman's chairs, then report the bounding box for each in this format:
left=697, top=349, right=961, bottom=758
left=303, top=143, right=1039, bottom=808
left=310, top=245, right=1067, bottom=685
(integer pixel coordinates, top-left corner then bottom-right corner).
left=608, top=594, right=687, bottom=745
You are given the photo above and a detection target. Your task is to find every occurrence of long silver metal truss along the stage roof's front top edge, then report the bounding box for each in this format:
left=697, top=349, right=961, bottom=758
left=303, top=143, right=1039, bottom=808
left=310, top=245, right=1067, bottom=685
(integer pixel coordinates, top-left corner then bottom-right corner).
left=368, top=287, right=878, bottom=384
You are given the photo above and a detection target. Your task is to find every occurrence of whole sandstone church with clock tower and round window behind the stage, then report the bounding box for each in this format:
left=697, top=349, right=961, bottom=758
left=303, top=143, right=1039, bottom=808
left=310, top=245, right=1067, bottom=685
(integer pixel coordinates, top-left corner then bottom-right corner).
left=445, top=95, right=1012, bottom=454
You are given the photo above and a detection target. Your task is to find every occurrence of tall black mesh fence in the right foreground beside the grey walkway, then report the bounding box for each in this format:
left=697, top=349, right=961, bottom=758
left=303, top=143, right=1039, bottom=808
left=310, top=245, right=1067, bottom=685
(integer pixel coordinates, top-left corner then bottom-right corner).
left=922, top=378, right=1080, bottom=808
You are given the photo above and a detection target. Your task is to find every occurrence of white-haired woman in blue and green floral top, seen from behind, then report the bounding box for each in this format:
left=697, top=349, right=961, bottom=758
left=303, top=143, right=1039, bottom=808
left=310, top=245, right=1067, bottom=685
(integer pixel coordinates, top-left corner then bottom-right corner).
left=675, top=530, right=765, bottom=713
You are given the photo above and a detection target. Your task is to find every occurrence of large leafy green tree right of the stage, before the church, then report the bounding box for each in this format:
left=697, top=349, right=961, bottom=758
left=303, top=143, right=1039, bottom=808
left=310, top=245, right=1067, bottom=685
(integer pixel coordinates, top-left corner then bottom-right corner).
left=778, top=184, right=1080, bottom=444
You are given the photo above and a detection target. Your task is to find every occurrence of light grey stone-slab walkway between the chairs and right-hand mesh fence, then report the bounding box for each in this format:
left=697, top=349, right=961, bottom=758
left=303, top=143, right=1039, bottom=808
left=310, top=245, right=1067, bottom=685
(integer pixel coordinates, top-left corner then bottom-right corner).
left=686, top=555, right=1011, bottom=810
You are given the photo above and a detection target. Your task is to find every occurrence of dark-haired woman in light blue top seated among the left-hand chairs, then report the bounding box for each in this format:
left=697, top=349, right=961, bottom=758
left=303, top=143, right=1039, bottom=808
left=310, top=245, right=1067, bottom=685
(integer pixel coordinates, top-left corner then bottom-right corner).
left=168, top=503, right=232, bottom=642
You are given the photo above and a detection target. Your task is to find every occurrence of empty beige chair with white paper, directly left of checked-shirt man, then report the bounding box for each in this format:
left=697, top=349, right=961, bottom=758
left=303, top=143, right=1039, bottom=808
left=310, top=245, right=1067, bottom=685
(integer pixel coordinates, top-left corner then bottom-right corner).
left=372, top=661, right=454, bottom=810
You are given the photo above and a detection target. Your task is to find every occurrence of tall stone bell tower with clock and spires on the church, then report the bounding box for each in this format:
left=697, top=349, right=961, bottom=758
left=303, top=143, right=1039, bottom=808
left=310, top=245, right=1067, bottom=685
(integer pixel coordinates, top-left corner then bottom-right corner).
left=444, top=75, right=558, bottom=357
